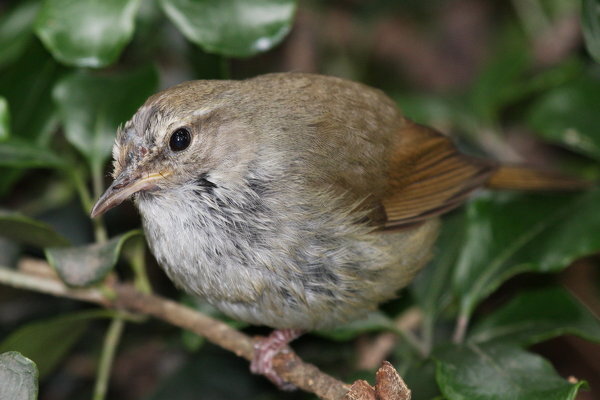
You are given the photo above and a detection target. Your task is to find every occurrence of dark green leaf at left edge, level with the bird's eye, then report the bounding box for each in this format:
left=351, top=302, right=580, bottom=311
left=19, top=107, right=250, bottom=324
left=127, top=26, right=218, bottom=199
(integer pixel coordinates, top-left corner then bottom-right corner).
left=0, top=140, right=66, bottom=168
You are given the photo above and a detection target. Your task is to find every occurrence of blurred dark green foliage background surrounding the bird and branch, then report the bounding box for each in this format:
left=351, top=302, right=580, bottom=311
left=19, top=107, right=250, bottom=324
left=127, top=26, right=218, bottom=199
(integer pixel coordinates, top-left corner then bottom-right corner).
left=0, top=0, right=600, bottom=400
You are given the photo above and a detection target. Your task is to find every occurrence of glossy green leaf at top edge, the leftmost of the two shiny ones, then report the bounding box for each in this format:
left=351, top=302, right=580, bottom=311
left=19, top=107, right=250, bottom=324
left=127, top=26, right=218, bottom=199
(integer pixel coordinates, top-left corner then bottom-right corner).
left=35, top=0, right=140, bottom=68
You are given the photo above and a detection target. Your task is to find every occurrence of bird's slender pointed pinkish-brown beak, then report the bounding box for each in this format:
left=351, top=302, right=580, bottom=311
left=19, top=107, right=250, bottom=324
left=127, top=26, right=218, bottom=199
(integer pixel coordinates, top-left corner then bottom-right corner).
left=91, top=171, right=169, bottom=218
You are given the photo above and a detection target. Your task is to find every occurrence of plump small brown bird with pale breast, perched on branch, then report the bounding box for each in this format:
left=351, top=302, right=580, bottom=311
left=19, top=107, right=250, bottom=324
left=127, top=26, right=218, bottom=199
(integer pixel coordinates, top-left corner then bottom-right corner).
left=92, top=73, right=579, bottom=386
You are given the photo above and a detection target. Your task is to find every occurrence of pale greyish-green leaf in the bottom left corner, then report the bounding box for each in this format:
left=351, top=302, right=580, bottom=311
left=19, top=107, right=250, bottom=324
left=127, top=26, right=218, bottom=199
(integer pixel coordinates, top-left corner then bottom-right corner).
left=0, top=351, right=38, bottom=400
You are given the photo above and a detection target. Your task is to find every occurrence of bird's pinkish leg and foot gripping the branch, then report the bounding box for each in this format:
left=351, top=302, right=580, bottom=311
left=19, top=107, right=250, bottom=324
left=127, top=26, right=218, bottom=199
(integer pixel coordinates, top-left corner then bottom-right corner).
left=250, top=329, right=303, bottom=390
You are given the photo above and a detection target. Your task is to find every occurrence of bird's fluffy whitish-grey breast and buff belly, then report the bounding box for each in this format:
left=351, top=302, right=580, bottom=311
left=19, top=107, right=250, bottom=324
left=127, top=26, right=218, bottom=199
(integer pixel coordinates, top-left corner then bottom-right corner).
left=137, top=183, right=437, bottom=329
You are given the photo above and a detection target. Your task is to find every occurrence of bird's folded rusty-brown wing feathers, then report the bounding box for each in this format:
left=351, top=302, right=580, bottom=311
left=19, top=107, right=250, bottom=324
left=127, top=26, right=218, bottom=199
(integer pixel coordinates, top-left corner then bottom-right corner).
left=382, top=120, right=496, bottom=229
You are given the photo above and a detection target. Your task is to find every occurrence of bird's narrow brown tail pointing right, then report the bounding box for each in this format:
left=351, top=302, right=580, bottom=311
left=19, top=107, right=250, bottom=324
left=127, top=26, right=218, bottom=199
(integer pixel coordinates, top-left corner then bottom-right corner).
left=486, top=166, right=594, bottom=191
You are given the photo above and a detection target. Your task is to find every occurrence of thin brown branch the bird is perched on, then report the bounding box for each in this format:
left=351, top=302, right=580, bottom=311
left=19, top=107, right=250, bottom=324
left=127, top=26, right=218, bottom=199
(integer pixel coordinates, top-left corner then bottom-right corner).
left=0, top=267, right=350, bottom=400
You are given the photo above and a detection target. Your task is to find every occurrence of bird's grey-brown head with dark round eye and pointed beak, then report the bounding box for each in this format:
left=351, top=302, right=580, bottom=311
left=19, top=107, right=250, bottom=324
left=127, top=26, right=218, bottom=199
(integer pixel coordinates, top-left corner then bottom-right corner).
left=91, top=81, right=253, bottom=217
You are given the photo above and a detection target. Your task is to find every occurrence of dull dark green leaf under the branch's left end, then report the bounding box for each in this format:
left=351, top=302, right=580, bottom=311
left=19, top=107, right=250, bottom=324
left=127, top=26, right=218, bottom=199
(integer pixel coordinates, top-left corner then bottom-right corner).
left=0, top=310, right=115, bottom=378
